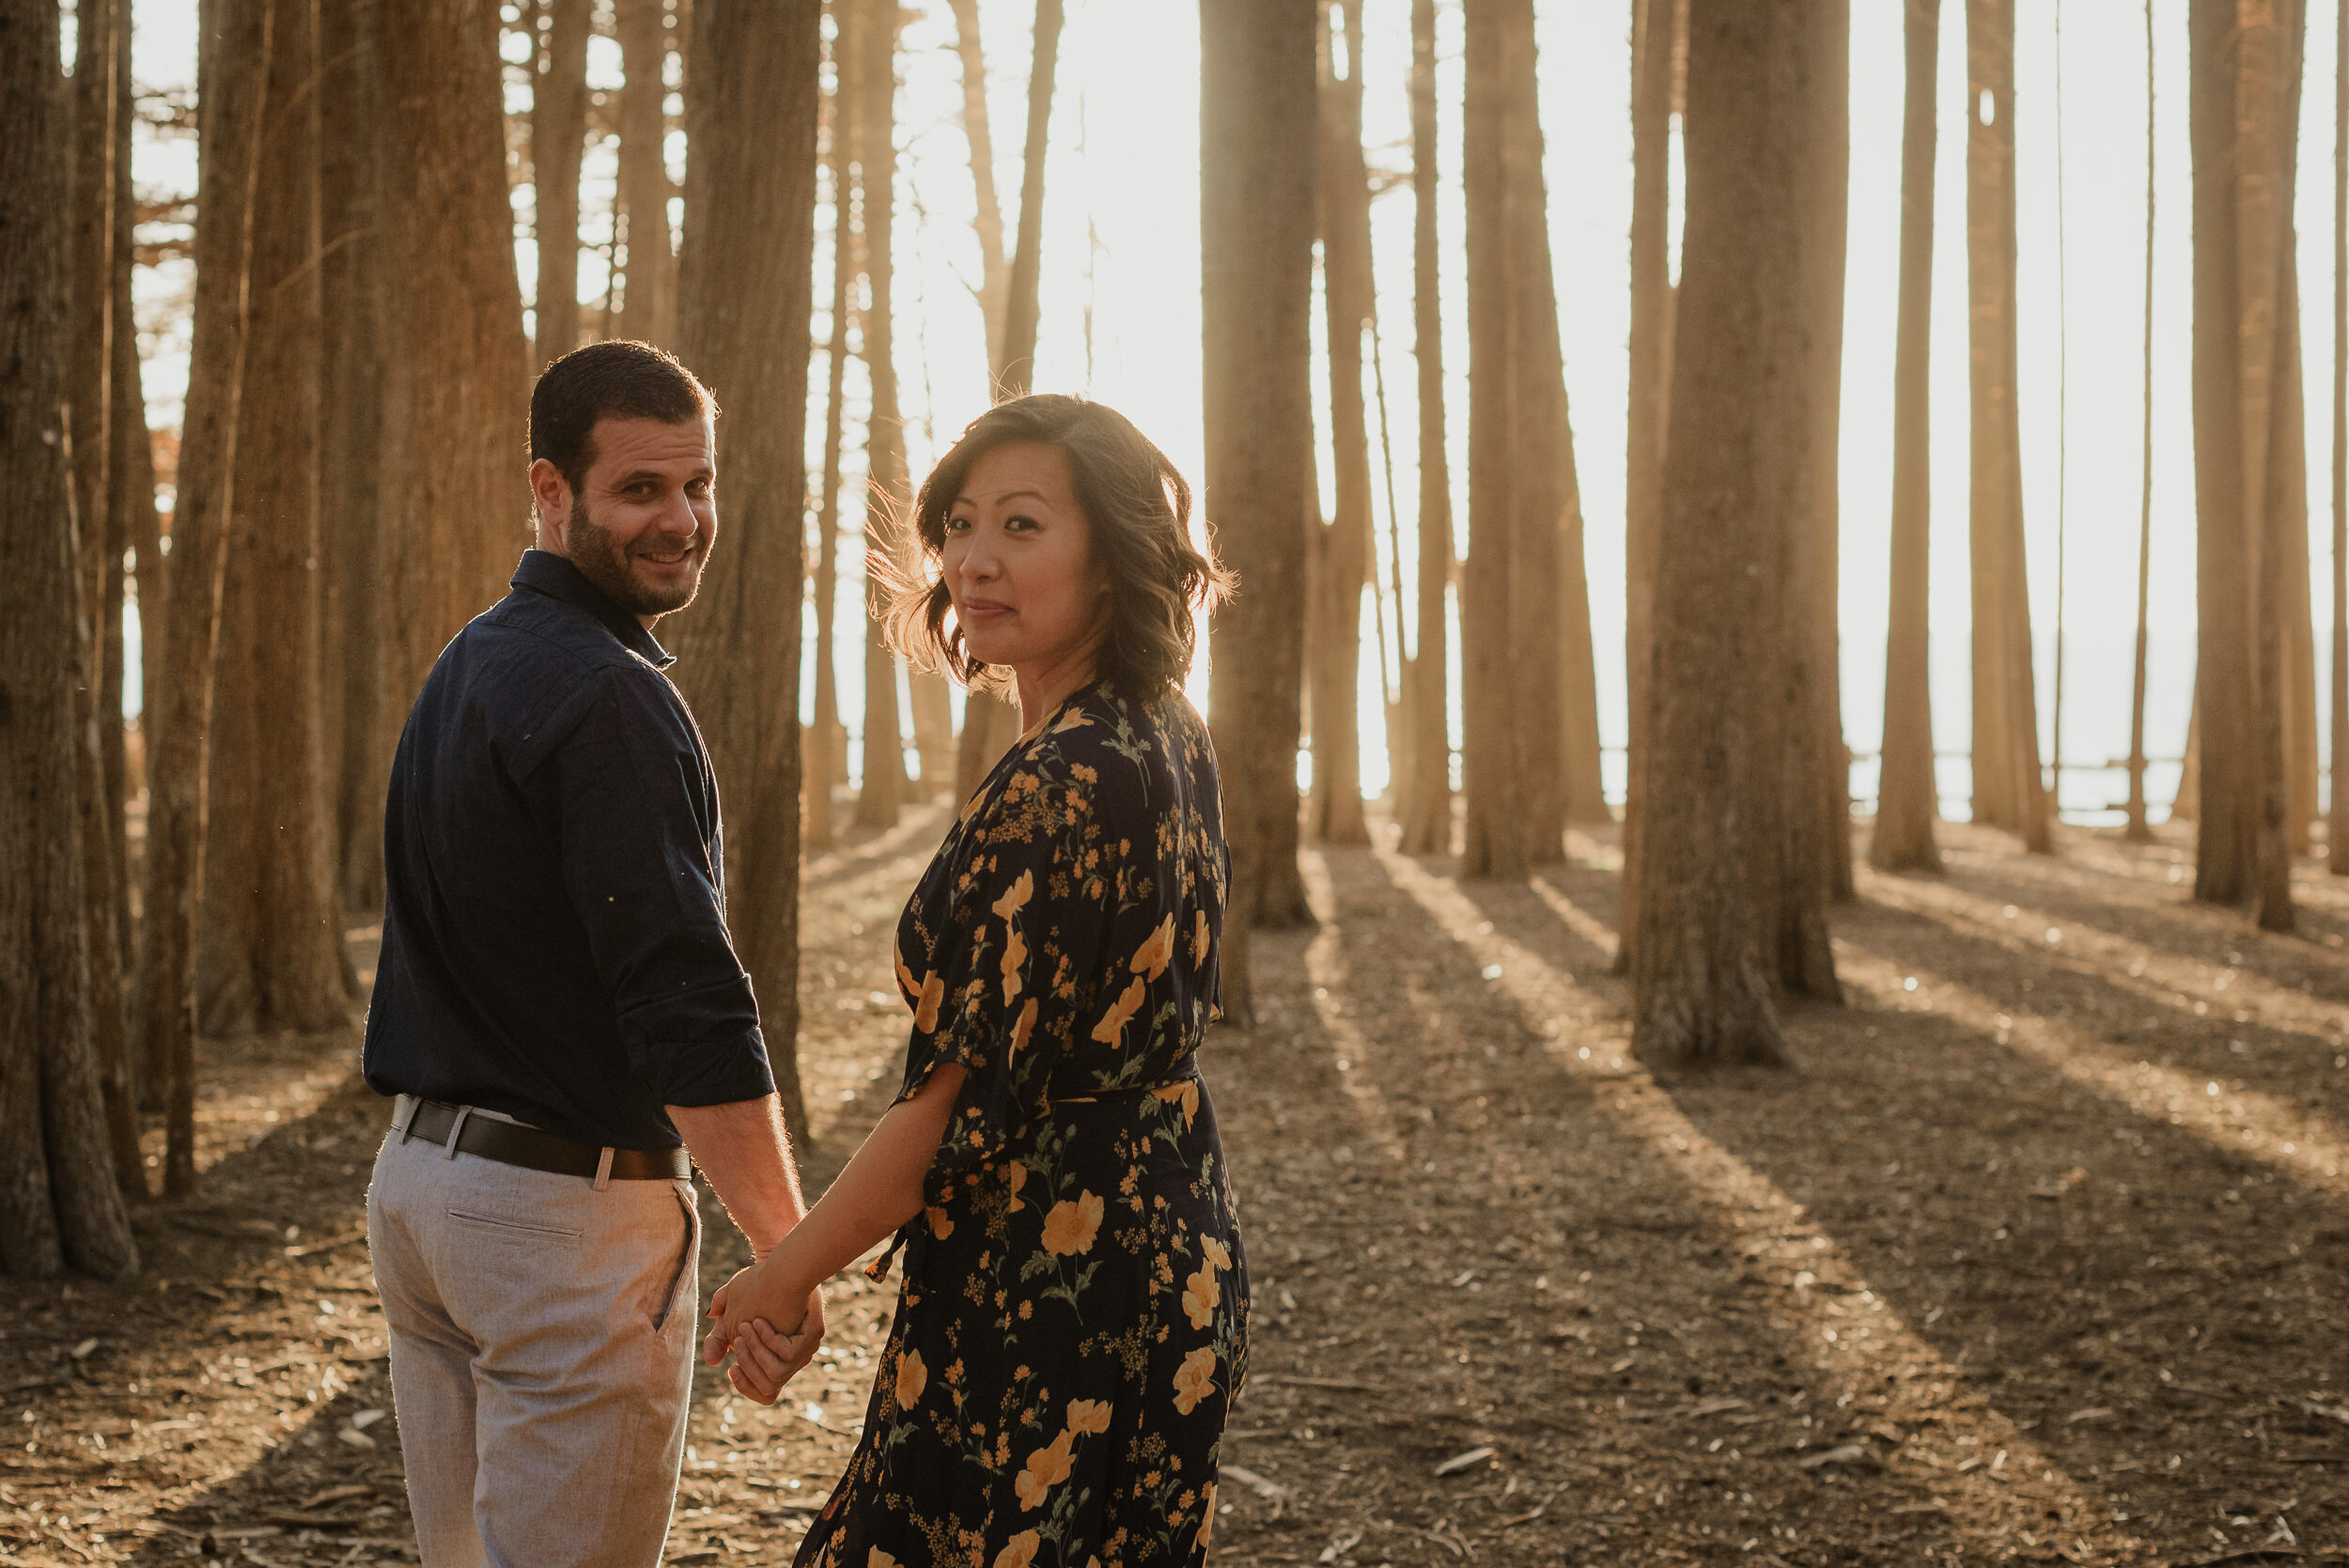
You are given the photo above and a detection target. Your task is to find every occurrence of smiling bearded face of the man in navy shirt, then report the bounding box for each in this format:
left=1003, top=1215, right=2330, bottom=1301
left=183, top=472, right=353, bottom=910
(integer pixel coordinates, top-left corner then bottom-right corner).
left=531, top=418, right=719, bottom=625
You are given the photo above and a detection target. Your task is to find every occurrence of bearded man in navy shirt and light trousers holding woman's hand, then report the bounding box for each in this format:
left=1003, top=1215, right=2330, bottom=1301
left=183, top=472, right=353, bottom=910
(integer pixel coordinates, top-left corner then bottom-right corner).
left=365, top=343, right=822, bottom=1568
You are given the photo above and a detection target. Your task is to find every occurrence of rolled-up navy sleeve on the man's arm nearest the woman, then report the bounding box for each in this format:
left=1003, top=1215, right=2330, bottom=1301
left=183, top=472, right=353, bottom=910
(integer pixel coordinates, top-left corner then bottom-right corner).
left=548, top=669, right=775, bottom=1106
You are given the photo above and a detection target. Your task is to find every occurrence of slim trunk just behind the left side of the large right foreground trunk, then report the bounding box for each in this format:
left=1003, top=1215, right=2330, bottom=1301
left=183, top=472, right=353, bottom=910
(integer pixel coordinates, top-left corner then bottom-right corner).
left=1614, top=0, right=1685, bottom=943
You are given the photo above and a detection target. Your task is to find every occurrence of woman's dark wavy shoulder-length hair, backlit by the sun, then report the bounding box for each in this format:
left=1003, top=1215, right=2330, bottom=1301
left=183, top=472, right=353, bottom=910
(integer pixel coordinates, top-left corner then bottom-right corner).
left=877, top=392, right=1234, bottom=700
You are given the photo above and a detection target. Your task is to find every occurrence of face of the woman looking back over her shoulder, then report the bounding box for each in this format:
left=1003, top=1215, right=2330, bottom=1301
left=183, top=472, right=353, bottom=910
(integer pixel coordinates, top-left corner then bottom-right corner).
left=940, top=442, right=1109, bottom=683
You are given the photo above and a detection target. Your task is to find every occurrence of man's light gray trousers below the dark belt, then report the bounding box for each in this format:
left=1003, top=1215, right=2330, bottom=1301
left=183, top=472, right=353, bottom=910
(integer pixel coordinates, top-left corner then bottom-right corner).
left=366, top=1112, right=700, bottom=1568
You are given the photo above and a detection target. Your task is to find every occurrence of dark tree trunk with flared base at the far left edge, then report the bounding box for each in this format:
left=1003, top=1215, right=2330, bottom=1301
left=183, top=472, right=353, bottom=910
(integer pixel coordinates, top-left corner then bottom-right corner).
left=0, top=0, right=139, bottom=1280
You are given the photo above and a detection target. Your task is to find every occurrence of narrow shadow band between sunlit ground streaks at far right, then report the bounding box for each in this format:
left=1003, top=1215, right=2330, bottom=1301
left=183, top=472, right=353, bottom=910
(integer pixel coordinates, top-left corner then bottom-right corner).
left=1840, top=887, right=2349, bottom=1159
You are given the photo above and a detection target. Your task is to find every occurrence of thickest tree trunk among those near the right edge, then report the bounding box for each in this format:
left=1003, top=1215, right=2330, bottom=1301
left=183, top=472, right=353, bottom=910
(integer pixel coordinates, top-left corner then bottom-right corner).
left=2189, top=0, right=2300, bottom=929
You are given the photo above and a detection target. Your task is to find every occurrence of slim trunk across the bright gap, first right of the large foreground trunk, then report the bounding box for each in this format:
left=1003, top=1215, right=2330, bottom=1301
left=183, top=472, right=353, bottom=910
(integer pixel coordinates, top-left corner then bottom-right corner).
left=1868, top=0, right=1940, bottom=871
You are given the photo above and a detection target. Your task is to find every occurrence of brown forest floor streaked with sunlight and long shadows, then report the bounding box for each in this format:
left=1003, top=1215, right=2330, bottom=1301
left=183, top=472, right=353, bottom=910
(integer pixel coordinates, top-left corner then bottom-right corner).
left=0, top=807, right=2349, bottom=1568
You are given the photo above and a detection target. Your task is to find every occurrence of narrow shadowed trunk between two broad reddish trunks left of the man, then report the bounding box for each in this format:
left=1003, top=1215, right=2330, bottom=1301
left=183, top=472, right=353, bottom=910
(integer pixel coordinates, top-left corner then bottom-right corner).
left=318, top=0, right=387, bottom=910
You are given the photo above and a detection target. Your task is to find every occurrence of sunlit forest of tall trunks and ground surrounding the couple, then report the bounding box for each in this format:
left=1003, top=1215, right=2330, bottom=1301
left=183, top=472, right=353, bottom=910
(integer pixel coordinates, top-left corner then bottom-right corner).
left=0, top=0, right=2349, bottom=1568
